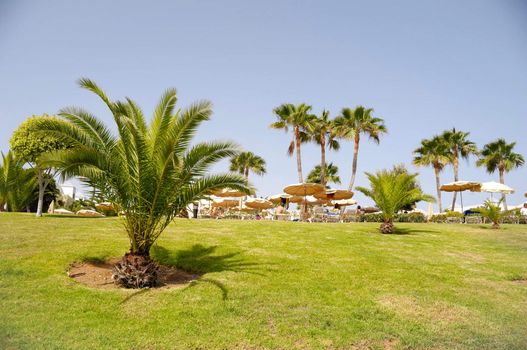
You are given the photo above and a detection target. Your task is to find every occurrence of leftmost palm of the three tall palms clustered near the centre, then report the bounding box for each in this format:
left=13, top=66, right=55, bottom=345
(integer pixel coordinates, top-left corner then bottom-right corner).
left=270, top=103, right=315, bottom=183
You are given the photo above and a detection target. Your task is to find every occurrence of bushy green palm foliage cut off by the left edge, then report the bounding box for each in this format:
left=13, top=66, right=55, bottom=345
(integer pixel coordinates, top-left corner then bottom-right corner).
left=0, top=151, right=38, bottom=211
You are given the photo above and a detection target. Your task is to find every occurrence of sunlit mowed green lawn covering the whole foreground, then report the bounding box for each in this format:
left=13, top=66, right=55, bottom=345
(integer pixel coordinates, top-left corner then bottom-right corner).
left=0, top=213, right=527, bottom=349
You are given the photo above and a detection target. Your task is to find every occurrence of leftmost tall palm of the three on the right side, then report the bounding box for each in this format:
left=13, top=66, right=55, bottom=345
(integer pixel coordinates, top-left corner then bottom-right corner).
left=413, top=136, right=451, bottom=212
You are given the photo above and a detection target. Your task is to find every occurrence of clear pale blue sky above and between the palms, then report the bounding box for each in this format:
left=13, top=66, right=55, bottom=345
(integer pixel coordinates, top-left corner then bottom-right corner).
left=0, top=0, right=527, bottom=209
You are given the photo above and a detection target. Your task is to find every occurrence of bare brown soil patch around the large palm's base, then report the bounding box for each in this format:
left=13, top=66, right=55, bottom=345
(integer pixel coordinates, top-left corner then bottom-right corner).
left=68, top=258, right=201, bottom=289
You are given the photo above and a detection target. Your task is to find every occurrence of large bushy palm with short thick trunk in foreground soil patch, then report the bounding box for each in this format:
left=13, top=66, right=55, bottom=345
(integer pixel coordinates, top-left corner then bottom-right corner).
left=32, top=79, right=249, bottom=287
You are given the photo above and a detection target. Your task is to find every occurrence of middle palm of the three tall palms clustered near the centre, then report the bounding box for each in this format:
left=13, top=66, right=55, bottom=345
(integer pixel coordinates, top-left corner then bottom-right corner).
left=308, top=110, right=340, bottom=186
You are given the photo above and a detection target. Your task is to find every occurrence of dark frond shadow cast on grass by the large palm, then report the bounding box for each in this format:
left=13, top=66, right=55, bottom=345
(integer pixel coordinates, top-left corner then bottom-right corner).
left=151, top=244, right=264, bottom=300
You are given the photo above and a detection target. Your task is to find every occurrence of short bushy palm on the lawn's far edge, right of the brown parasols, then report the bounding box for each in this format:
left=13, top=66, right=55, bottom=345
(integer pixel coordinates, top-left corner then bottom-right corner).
left=356, top=168, right=434, bottom=233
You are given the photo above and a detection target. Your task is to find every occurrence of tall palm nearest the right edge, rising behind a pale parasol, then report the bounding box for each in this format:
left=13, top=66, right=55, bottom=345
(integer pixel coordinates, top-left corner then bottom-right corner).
left=476, top=138, right=525, bottom=210
